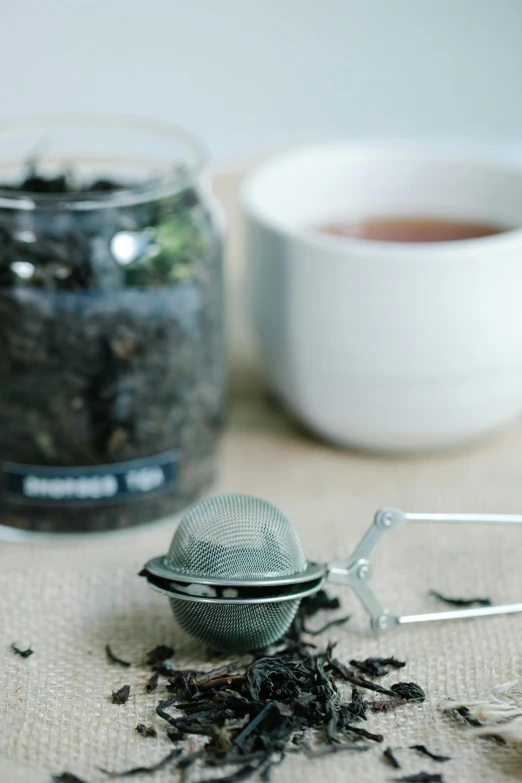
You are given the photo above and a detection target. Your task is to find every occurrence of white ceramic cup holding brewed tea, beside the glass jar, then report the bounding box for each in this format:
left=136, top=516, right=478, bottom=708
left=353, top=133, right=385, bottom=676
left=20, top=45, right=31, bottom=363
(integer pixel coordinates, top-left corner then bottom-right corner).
left=242, top=143, right=522, bottom=452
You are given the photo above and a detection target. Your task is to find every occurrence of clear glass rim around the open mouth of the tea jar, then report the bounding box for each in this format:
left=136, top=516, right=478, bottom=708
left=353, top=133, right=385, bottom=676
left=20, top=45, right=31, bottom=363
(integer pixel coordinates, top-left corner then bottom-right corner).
left=0, top=114, right=208, bottom=211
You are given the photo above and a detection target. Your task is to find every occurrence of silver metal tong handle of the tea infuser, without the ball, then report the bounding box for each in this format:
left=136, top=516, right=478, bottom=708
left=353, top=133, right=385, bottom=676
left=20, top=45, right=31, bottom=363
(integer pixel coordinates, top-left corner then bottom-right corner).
left=327, top=508, right=522, bottom=631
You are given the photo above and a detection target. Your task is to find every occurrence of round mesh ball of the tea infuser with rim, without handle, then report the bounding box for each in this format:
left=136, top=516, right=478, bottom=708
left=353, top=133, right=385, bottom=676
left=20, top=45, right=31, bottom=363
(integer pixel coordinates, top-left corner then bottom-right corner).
left=140, top=495, right=324, bottom=652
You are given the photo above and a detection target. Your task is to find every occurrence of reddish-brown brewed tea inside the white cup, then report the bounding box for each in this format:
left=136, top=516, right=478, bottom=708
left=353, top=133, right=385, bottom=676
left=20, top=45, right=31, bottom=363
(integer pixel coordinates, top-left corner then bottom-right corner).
left=319, top=217, right=508, bottom=242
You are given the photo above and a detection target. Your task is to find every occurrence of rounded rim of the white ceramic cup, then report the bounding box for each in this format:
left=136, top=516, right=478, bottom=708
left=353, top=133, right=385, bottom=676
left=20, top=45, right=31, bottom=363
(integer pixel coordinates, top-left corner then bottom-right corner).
left=240, top=140, right=522, bottom=256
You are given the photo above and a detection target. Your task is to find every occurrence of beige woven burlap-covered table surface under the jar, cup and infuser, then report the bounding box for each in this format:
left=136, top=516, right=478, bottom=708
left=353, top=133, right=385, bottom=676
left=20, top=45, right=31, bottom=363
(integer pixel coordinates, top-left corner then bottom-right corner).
left=0, top=176, right=522, bottom=783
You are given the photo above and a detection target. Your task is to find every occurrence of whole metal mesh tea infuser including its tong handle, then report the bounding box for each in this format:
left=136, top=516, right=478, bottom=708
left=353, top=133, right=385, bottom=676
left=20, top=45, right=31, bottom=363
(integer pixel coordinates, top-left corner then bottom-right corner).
left=141, top=495, right=522, bottom=653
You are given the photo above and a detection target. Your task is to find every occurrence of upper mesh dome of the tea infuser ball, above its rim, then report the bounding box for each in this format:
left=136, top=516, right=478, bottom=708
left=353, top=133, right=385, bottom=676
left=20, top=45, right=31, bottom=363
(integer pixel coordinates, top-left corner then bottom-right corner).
left=166, top=495, right=306, bottom=579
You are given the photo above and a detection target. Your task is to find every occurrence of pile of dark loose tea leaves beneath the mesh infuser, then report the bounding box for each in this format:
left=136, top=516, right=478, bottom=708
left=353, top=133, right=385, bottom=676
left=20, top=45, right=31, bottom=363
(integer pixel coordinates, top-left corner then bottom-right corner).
left=92, top=591, right=430, bottom=783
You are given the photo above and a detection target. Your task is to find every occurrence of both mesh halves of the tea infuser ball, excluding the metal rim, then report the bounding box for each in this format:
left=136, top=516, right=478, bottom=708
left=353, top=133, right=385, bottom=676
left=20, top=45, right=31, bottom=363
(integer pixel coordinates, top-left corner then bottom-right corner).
left=166, top=495, right=307, bottom=652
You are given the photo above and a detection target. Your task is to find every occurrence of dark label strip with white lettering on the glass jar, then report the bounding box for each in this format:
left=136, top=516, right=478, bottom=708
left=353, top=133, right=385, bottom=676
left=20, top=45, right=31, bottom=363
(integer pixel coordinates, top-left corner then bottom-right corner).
left=1, top=451, right=179, bottom=506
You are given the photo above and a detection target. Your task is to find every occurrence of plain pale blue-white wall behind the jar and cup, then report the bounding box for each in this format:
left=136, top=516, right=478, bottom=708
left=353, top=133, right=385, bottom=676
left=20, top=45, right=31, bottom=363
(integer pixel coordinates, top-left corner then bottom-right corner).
left=0, top=0, right=522, bottom=162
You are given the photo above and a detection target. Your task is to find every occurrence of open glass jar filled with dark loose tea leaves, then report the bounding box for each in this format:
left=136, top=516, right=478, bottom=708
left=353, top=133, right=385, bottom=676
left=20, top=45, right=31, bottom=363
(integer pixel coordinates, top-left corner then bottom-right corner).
left=0, top=117, right=225, bottom=535
